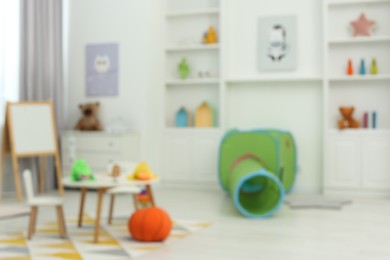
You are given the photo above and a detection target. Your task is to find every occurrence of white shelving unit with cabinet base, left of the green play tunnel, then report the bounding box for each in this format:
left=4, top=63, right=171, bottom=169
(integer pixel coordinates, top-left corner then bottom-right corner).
left=162, top=0, right=224, bottom=183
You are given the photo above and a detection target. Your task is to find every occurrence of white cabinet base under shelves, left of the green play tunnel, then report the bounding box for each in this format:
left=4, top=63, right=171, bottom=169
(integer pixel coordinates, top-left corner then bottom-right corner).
left=163, top=130, right=221, bottom=182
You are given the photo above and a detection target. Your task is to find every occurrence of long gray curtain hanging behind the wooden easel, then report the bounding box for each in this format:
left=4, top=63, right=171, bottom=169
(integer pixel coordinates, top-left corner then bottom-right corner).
left=20, top=0, right=65, bottom=191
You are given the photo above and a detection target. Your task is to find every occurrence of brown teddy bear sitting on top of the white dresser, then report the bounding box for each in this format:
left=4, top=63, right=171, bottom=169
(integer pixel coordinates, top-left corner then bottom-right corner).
left=75, top=102, right=102, bottom=131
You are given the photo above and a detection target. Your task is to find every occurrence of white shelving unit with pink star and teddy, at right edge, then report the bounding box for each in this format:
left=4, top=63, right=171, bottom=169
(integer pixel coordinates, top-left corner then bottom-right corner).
left=323, top=0, right=390, bottom=194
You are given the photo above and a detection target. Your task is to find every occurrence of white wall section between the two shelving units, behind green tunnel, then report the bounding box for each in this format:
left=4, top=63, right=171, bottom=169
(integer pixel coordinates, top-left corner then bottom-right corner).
left=225, top=0, right=323, bottom=192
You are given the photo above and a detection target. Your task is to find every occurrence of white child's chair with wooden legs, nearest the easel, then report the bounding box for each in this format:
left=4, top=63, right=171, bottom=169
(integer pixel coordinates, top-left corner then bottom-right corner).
left=23, top=170, right=67, bottom=239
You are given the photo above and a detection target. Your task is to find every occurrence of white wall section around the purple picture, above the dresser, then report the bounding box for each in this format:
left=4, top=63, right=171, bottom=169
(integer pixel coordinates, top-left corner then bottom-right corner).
left=66, top=0, right=159, bottom=164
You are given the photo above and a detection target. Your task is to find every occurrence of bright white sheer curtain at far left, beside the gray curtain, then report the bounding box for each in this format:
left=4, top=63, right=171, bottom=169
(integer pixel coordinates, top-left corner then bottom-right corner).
left=0, top=0, right=21, bottom=195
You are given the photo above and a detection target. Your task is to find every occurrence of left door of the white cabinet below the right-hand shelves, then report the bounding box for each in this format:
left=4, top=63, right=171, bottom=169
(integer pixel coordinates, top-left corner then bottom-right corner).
left=326, top=135, right=361, bottom=188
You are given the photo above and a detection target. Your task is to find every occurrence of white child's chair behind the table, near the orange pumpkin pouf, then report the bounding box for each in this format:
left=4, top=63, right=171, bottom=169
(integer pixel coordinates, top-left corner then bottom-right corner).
left=107, top=162, right=142, bottom=225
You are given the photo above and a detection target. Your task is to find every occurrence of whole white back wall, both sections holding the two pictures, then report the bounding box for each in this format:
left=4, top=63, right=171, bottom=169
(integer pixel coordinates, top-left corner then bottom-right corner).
left=67, top=0, right=322, bottom=192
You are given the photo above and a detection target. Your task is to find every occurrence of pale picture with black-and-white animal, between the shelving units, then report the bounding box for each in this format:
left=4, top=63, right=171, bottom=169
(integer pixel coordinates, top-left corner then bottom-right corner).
left=258, top=16, right=297, bottom=71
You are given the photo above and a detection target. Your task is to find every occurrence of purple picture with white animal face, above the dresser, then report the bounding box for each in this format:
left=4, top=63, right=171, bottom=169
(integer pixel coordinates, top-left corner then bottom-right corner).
left=86, top=43, right=119, bottom=97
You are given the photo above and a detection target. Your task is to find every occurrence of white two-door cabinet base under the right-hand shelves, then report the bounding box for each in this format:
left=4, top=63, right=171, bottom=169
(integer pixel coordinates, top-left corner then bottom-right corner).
left=325, top=130, right=390, bottom=193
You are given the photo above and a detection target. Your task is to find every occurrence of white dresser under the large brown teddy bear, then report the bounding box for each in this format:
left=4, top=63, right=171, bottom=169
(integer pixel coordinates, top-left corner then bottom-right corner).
left=61, top=131, right=140, bottom=176
